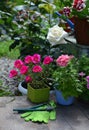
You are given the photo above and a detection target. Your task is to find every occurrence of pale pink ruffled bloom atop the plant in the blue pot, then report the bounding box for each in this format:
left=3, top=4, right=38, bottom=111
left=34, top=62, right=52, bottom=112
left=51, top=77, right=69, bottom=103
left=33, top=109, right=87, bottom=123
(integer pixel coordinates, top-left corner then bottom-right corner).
left=56, top=55, right=73, bottom=67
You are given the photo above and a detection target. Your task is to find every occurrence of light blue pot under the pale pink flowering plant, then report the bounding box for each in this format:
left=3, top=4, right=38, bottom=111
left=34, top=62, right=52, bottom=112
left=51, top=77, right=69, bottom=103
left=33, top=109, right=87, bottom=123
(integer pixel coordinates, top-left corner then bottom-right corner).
left=55, top=89, right=74, bottom=105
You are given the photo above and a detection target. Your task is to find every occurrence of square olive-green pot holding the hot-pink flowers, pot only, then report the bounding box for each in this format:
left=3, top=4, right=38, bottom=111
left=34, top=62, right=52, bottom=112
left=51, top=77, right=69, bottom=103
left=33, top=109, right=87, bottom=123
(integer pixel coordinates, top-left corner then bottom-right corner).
left=27, top=85, right=50, bottom=103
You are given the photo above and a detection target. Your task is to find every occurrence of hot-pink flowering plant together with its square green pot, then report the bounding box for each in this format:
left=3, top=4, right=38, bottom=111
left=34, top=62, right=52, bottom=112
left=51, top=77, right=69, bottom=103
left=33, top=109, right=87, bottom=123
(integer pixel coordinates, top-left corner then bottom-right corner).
left=9, top=54, right=53, bottom=103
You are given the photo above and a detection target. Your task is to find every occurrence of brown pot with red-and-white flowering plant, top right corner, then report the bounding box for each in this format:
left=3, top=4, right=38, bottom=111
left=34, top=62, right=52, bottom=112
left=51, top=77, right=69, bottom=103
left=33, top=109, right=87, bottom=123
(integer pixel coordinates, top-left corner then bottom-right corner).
left=59, top=0, right=89, bottom=45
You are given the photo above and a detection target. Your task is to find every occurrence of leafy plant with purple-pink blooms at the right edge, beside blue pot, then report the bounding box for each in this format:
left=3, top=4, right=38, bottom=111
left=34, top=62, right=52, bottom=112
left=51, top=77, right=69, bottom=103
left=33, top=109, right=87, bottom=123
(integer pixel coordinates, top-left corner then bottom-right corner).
left=78, top=55, right=89, bottom=104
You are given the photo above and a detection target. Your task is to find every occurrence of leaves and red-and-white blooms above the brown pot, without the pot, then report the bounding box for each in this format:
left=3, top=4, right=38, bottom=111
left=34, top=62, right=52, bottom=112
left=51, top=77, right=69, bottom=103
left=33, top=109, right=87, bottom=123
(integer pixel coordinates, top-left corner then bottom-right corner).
left=59, top=0, right=89, bottom=19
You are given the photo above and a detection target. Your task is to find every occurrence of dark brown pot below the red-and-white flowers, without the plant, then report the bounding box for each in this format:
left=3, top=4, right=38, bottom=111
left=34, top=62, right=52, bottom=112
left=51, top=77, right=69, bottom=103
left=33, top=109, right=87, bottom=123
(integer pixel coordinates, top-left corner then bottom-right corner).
left=74, top=17, right=89, bottom=46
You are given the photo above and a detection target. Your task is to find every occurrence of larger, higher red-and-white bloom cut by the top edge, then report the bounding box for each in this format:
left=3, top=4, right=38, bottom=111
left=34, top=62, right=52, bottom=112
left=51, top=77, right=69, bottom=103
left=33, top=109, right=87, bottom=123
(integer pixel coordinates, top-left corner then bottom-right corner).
left=73, top=0, right=86, bottom=11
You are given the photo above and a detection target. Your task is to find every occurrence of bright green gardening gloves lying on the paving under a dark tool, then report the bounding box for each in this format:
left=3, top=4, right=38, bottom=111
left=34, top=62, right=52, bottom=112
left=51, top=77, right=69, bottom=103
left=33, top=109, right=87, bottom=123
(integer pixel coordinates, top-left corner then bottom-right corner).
left=21, top=101, right=56, bottom=123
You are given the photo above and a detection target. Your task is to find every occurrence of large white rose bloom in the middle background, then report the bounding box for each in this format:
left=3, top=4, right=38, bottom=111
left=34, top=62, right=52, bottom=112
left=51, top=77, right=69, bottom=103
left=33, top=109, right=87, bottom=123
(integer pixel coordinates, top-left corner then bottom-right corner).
left=47, top=25, right=68, bottom=45
